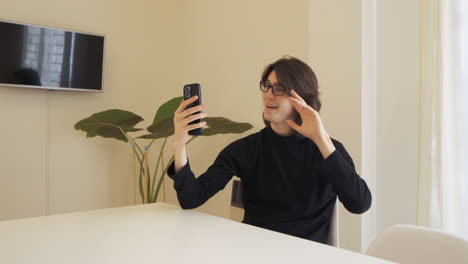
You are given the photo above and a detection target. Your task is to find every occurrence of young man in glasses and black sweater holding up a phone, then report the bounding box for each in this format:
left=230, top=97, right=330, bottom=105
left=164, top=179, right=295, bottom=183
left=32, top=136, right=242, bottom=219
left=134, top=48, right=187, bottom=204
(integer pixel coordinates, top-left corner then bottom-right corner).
left=168, top=57, right=372, bottom=243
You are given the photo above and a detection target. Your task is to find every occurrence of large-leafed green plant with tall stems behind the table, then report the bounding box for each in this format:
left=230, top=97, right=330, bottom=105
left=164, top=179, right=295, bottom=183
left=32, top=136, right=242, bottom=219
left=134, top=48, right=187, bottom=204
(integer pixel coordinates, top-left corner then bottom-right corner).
left=74, top=97, right=252, bottom=203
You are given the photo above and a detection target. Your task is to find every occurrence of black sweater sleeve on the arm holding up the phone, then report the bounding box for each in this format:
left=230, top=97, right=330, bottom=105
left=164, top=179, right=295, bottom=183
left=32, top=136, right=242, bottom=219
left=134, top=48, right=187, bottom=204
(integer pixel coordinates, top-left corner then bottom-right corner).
left=167, top=139, right=245, bottom=209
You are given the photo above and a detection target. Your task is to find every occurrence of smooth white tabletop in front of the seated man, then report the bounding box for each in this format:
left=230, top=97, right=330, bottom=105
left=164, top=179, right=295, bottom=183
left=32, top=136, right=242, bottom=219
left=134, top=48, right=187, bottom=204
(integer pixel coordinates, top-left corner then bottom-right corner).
left=0, top=203, right=391, bottom=264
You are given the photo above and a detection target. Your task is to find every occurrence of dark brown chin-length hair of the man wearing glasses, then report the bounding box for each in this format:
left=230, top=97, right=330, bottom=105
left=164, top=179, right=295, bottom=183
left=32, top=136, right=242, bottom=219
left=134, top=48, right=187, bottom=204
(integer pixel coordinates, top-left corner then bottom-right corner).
left=261, top=56, right=322, bottom=126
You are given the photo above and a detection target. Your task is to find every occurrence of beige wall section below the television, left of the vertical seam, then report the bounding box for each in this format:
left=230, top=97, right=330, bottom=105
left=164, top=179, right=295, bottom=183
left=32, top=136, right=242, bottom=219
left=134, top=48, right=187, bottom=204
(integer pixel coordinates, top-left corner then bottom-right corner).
left=0, top=88, right=47, bottom=220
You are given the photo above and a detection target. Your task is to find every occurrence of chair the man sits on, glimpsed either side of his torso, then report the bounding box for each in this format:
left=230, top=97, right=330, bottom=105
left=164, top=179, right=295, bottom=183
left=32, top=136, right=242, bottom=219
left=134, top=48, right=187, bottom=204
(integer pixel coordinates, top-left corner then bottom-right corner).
left=231, top=179, right=340, bottom=247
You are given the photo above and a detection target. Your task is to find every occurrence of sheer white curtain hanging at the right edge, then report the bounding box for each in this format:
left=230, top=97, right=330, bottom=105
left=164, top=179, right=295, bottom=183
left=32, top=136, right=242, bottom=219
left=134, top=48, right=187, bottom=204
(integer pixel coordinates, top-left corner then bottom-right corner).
left=418, top=0, right=468, bottom=239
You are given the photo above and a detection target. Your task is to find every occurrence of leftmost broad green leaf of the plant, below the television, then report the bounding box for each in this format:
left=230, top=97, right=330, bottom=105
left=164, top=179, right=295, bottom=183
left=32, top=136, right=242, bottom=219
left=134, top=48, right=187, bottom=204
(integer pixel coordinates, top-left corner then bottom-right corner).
left=75, top=109, right=143, bottom=142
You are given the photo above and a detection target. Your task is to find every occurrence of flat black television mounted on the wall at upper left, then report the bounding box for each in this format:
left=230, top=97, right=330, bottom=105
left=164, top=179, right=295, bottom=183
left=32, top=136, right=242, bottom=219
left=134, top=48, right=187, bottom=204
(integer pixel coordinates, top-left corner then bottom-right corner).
left=0, top=20, right=104, bottom=92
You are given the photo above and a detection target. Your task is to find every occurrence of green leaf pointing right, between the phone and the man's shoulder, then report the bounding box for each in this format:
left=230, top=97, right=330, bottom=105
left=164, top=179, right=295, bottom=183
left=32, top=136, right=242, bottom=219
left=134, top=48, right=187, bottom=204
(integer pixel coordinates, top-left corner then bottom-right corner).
left=202, top=117, right=253, bottom=136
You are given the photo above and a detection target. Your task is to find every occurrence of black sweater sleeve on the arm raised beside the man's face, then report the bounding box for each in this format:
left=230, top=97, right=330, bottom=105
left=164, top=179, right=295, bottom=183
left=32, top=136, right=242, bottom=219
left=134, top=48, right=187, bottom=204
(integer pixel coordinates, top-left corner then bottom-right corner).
left=322, top=140, right=372, bottom=214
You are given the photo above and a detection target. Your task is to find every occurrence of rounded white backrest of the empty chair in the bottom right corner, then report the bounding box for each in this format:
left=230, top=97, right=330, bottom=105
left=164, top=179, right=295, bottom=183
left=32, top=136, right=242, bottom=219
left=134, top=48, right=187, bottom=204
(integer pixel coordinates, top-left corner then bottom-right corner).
left=366, top=225, right=468, bottom=264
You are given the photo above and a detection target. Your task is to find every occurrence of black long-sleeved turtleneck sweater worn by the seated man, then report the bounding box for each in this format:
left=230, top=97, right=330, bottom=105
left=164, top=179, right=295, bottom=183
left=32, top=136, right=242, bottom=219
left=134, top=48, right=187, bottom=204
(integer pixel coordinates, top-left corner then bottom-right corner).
left=168, top=127, right=372, bottom=243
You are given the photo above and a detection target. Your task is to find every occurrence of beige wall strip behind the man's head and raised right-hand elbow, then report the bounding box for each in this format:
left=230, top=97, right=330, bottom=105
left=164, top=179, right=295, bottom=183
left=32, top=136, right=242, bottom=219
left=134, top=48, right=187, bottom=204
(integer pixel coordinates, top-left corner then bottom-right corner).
left=309, top=0, right=361, bottom=251
